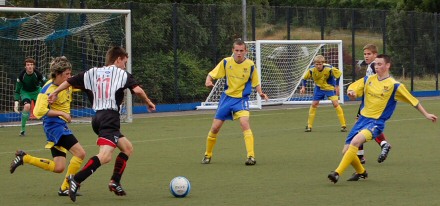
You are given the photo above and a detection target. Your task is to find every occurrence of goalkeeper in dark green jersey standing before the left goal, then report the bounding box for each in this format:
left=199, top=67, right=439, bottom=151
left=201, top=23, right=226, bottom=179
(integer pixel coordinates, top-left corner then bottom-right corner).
left=14, top=57, right=46, bottom=136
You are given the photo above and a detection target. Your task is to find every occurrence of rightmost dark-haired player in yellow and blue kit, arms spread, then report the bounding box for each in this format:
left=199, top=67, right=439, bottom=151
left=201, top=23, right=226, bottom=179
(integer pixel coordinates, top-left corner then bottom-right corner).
left=327, top=54, right=437, bottom=183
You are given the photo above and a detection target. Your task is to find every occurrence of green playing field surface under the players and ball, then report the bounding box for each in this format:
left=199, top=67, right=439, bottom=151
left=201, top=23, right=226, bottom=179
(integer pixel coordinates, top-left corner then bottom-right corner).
left=0, top=98, right=440, bottom=206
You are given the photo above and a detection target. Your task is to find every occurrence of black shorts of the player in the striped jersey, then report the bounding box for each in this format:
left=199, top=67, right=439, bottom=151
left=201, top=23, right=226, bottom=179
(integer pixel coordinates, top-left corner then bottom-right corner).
left=92, top=110, right=124, bottom=145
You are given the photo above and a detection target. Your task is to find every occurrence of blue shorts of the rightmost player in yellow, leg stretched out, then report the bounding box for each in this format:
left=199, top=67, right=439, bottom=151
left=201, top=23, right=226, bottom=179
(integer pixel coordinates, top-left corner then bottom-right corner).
left=345, top=115, right=385, bottom=144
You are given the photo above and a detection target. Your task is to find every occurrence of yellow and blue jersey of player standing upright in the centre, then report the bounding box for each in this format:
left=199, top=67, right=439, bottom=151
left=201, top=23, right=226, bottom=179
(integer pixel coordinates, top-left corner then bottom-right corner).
left=209, top=57, right=260, bottom=98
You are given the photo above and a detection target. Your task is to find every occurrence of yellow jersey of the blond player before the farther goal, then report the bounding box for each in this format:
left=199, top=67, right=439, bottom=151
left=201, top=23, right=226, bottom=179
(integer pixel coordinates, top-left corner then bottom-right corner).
left=303, top=64, right=342, bottom=91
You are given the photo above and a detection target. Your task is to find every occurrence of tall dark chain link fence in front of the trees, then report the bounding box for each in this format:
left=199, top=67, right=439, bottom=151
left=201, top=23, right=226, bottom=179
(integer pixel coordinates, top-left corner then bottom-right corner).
left=0, top=0, right=440, bottom=104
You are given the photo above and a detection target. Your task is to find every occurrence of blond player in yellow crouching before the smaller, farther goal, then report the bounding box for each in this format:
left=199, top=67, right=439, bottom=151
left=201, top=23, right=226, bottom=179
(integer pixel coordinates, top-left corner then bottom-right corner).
left=300, top=55, right=347, bottom=132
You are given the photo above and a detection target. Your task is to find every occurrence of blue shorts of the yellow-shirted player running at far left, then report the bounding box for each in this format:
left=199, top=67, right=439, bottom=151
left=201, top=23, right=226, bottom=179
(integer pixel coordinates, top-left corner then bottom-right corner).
left=43, top=117, right=73, bottom=144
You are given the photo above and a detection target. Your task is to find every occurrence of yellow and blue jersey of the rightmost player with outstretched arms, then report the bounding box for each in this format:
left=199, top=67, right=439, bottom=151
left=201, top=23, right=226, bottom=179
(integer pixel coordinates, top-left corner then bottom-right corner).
left=348, top=74, right=419, bottom=120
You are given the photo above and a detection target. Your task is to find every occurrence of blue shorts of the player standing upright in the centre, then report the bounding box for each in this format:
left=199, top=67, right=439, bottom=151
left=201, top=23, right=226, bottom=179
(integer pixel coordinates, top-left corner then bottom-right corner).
left=215, top=93, right=249, bottom=120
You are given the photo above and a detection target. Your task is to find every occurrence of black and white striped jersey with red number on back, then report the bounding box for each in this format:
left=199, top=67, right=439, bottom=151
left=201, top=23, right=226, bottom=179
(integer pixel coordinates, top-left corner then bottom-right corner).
left=67, top=65, right=139, bottom=111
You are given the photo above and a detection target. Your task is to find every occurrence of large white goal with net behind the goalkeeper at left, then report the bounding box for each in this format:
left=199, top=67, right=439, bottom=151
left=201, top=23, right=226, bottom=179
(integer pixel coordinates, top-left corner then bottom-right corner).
left=0, top=7, right=133, bottom=126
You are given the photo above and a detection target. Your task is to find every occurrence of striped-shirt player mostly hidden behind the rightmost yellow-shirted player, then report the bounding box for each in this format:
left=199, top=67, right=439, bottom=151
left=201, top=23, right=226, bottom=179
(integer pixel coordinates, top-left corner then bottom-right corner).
left=353, top=44, right=391, bottom=165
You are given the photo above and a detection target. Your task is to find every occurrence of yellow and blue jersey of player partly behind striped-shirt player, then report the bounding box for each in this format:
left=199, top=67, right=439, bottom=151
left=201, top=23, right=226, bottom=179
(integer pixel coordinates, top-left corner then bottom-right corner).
left=33, top=80, right=73, bottom=122
